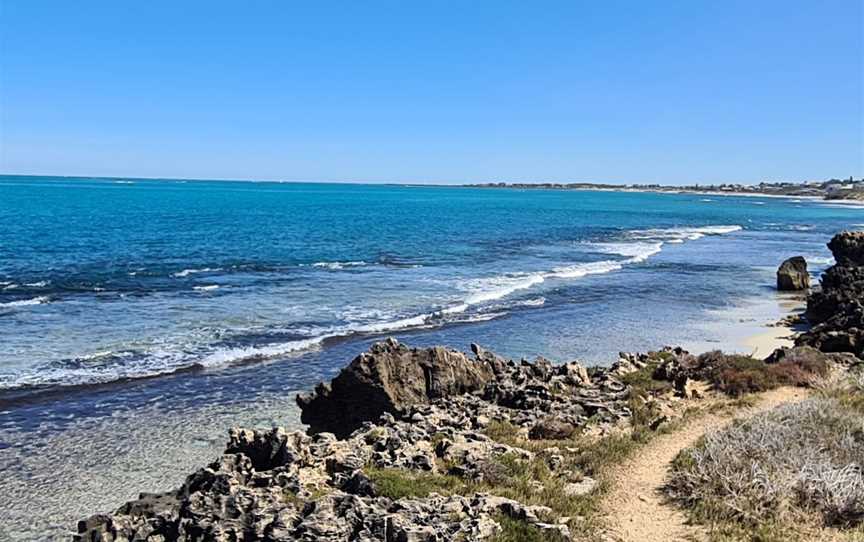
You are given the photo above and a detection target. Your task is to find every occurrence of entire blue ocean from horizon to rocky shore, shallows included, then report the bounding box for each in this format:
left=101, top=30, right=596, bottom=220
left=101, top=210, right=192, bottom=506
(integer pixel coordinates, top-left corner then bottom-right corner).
left=0, top=176, right=864, bottom=540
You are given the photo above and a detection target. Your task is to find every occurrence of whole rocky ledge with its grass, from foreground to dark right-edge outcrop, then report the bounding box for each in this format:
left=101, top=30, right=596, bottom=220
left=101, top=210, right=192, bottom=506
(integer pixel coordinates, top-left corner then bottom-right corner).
left=73, top=233, right=864, bottom=542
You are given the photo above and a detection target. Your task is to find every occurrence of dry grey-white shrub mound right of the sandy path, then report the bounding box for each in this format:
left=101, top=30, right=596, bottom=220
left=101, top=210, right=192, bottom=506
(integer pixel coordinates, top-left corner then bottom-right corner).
left=668, top=397, right=864, bottom=540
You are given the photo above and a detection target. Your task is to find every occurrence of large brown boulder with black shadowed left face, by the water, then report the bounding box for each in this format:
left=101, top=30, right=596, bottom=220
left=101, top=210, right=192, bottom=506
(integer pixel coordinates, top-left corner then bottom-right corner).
left=297, top=338, right=494, bottom=438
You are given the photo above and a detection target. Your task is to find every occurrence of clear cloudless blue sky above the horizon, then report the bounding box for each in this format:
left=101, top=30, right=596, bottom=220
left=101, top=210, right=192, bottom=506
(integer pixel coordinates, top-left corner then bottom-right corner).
left=0, top=0, right=864, bottom=184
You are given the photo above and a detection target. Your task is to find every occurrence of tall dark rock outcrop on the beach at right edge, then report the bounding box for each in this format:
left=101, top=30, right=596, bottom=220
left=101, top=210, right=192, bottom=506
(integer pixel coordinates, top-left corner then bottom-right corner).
left=796, top=232, right=864, bottom=358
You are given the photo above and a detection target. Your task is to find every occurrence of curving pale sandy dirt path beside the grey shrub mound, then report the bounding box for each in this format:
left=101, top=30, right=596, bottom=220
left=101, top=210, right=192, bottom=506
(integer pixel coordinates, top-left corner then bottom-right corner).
left=604, top=388, right=808, bottom=542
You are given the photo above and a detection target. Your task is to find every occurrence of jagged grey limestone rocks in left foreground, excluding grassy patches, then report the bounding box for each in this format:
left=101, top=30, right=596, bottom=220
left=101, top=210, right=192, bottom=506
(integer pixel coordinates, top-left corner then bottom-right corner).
left=75, top=339, right=683, bottom=542
